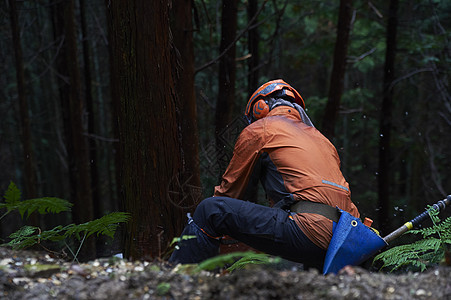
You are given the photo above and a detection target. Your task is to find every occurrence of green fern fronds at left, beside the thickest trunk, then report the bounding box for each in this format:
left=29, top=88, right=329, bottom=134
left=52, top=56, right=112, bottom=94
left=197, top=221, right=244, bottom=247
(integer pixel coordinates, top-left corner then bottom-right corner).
left=0, top=182, right=130, bottom=260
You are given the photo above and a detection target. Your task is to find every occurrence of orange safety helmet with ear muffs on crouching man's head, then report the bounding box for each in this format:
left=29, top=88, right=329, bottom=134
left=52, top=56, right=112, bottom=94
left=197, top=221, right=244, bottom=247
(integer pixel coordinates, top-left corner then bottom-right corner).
left=244, top=79, right=305, bottom=121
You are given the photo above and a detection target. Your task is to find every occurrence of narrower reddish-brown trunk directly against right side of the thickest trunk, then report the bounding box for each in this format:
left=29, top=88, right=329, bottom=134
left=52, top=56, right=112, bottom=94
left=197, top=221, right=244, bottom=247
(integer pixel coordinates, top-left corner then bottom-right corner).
left=171, top=0, right=202, bottom=209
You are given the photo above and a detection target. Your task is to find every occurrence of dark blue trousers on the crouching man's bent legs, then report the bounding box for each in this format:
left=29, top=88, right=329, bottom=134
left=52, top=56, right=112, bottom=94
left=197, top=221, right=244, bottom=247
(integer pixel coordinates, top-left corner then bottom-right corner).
left=169, top=197, right=326, bottom=270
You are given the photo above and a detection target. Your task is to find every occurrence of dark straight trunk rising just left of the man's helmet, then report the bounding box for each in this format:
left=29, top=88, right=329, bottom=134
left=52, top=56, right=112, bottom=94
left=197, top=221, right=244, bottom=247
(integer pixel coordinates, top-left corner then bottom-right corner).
left=215, top=0, right=238, bottom=176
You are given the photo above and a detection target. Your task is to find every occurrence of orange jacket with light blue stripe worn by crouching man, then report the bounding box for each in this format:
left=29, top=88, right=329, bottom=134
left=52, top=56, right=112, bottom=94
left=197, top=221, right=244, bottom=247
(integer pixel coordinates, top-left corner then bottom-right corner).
left=214, top=106, right=360, bottom=249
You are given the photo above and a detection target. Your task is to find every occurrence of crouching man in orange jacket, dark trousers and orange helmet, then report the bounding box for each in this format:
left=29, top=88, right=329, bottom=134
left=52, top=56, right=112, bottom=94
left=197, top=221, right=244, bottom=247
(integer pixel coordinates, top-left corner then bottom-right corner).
left=170, top=79, right=359, bottom=269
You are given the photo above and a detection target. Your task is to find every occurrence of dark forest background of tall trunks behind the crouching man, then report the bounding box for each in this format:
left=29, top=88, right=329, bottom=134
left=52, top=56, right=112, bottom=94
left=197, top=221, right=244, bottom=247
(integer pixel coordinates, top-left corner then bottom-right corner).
left=0, top=0, right=451, bottom=258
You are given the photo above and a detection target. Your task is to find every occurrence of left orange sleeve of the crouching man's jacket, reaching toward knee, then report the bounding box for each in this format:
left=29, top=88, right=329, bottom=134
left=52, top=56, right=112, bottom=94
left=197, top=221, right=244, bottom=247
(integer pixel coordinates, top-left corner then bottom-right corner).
left=214, top=122, right=264, bottom=200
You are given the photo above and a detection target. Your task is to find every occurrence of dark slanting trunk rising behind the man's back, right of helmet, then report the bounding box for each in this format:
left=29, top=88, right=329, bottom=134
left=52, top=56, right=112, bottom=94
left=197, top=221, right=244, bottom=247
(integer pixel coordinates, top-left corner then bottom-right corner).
left=322, top=0, right=352, bottom=140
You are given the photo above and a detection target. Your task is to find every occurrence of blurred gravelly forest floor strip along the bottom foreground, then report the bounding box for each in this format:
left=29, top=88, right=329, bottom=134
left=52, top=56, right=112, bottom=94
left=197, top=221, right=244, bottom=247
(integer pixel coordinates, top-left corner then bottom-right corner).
left=0, top=247, right=451, bottom=300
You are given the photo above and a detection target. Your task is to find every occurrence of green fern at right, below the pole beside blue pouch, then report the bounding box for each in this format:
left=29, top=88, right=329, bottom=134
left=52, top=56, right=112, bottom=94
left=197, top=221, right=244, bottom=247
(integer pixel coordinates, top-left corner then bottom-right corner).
left=374, top=208, right=451, bottom=272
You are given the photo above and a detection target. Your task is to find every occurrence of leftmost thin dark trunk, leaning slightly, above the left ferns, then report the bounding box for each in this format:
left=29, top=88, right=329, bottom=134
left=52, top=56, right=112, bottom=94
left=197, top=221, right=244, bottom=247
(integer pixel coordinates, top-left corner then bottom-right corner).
left=9, top=0, right=37, bottom=202
